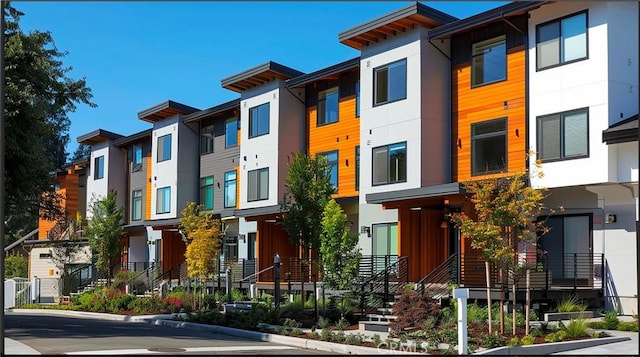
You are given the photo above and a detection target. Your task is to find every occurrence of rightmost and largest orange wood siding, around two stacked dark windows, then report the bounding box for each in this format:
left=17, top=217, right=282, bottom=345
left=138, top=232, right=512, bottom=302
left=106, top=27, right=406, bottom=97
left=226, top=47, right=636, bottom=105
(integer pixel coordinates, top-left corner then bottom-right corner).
left=452, top=47, right=527, bottom=182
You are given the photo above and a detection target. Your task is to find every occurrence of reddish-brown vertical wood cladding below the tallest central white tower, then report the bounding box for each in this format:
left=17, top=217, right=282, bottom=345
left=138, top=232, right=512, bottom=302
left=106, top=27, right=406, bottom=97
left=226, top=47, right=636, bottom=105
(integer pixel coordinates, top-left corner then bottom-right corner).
left=398, top=208, right=449, bottom=281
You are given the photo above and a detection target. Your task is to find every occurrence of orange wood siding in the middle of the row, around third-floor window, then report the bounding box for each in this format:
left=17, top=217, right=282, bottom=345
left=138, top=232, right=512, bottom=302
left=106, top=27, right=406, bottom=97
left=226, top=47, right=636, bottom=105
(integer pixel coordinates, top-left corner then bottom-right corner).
left=307, top=96, right=360, bottom=198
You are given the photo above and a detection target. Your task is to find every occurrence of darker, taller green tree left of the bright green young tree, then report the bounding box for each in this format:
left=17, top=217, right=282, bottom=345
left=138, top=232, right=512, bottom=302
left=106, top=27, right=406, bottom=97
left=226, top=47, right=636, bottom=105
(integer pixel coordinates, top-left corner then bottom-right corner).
left=280, top=152, right=335, bottom=258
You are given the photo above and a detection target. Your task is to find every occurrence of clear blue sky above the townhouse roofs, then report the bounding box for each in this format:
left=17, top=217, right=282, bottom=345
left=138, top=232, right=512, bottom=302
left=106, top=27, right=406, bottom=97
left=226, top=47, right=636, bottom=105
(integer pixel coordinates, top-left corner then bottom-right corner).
left=12, top=1, right=506, bottom=154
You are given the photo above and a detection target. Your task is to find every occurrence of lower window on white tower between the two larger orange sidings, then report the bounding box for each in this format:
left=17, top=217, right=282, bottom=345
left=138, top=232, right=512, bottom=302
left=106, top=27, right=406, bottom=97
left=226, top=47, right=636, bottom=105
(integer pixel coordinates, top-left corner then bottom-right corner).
left=372, top=142, right=407, bottom=185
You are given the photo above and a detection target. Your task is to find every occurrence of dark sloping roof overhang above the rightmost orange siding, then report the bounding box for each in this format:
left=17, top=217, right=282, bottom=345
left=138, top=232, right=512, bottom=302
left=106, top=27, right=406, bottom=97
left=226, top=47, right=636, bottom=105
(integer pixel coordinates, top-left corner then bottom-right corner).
left=429, top=1, right=550, bottom=39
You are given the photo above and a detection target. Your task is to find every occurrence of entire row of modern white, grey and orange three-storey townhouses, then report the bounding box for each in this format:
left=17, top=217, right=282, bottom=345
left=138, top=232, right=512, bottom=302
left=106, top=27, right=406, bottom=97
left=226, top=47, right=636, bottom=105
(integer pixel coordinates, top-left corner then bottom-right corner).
left=31, top=1, right=640, bottom=314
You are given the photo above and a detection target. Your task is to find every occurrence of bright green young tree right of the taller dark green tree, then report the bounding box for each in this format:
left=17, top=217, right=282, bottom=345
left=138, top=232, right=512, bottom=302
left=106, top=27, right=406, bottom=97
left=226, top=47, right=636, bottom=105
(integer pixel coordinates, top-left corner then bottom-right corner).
left=320, top=199, right=361, bottom=290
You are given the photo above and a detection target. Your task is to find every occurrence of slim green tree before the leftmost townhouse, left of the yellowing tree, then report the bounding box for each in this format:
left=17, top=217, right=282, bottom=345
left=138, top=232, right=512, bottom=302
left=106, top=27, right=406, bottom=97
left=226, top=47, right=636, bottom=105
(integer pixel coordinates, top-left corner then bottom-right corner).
left=85, top=190, right=124, bottom=278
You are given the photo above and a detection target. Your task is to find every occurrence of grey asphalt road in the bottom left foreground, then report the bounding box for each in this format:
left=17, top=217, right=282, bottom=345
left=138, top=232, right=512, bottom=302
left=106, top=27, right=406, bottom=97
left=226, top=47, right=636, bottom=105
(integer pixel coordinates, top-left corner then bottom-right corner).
left=5, top=312, right=326, bottom=355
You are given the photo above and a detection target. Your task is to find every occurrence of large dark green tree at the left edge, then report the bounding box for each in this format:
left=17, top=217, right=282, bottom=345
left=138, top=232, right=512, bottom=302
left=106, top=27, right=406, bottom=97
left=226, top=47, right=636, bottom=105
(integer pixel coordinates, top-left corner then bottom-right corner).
left=1, top=1, right=96, bottom=240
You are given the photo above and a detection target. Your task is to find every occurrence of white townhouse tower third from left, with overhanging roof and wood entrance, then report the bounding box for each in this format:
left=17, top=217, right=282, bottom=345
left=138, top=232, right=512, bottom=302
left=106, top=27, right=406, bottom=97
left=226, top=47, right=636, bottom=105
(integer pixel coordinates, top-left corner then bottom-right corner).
left=221, top=62, right=305, bottom=276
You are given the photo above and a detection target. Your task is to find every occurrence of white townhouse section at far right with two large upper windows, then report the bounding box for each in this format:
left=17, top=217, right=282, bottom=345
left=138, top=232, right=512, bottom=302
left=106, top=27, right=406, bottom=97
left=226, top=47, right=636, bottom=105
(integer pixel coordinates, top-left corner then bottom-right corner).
left=527, top=2, right=638, bottom=314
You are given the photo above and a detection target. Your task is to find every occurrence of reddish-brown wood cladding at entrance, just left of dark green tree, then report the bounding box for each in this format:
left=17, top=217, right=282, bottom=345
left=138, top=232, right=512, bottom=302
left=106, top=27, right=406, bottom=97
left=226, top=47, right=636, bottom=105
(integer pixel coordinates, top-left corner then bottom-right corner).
left=256, top=220, right=298, bottom=281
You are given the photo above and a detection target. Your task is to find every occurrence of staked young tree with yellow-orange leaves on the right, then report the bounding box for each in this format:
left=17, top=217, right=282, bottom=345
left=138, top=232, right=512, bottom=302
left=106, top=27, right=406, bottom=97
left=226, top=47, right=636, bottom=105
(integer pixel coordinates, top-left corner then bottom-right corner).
left=452, top=167, right=545, bottom=333
